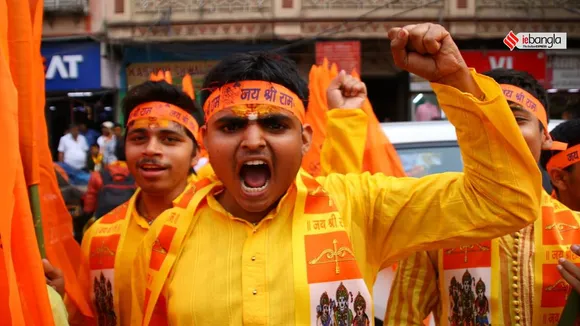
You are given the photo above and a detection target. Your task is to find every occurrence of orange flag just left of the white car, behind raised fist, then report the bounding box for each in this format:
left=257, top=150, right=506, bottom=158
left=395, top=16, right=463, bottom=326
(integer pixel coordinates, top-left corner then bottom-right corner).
left=352, top=70, right=406, bottom=177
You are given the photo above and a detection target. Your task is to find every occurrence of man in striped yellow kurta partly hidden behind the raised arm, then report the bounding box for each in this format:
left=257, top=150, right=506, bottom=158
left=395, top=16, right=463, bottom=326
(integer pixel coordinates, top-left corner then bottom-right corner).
left=385, top=69, right=580, bottom=326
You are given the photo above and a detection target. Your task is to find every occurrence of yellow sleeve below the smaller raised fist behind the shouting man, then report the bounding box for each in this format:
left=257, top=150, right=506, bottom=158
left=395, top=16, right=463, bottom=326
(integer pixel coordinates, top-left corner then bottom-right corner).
left=320, top=109, right=368, bottom=175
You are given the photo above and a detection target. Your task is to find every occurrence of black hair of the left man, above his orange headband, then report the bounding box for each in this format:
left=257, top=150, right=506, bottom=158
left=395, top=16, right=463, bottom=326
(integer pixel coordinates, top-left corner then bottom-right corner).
left=123, top=80, right=203, bottom=146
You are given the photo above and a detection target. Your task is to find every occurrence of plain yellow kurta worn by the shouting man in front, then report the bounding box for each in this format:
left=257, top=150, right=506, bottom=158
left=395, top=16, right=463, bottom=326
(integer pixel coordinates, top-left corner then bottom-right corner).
left=133, top=70, right=541, bottom=325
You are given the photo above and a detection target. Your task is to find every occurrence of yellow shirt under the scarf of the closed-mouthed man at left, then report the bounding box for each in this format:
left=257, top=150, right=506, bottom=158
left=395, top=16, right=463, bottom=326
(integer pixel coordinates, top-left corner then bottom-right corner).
left=81, top=186, right=189, bottom=325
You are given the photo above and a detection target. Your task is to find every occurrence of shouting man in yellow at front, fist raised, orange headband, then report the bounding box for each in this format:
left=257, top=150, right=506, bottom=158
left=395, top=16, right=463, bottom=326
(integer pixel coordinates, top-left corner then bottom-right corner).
left=132, top=24, right=541, bottom=325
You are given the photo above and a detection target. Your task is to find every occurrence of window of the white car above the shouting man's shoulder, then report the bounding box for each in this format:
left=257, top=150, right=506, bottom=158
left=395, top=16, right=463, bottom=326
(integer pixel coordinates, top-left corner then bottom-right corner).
left=395, top=142, right=463, bottom=177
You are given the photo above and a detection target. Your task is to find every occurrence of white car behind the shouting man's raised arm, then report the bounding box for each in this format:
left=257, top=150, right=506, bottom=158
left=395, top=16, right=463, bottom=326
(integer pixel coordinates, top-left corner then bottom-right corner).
left=373, top=120, right=563, bottom=326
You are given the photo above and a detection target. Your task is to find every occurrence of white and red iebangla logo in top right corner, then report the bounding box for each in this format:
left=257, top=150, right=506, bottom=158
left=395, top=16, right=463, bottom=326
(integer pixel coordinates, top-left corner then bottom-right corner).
left=503, top=31, right=567, bottom=51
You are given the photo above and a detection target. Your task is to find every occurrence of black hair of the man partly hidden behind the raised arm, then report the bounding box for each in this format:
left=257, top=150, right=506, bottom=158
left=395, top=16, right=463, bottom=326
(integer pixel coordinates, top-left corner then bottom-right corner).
left=483, top=68, right=550, bottom=125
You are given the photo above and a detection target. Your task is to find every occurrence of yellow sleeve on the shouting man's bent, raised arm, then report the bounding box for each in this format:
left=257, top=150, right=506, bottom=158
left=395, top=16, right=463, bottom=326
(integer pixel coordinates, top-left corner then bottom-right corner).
left=317, top=72, right=542, bottom=267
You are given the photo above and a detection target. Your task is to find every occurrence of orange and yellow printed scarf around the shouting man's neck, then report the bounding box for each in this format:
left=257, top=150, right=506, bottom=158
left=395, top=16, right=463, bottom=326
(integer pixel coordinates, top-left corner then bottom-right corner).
left=134, top=170, right=373, bottom=325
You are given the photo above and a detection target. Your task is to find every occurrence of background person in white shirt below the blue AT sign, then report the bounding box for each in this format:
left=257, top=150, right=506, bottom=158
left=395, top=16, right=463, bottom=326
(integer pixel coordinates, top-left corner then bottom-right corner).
left=58, top=125, right=89, bottom=185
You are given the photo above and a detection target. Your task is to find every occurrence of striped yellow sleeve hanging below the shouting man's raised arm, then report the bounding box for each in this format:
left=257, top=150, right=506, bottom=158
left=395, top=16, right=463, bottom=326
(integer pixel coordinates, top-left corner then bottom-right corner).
left=384, top=251, right=439, bottom=326
